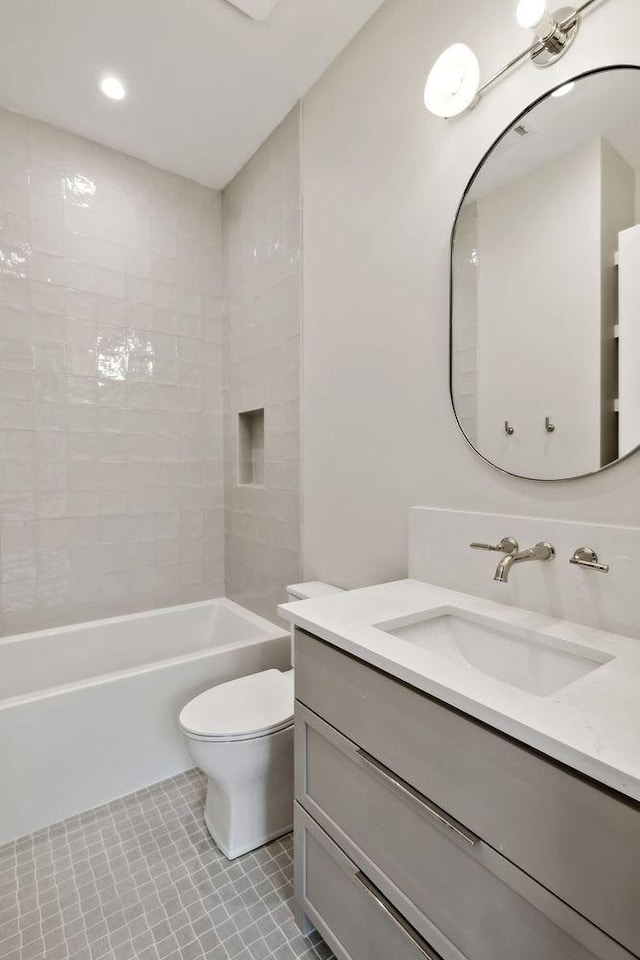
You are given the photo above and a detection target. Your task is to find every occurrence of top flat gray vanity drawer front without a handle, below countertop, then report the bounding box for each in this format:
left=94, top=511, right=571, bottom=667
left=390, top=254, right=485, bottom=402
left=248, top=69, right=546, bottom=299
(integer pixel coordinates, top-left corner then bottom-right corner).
left=296, top=630, right=640, bottom=955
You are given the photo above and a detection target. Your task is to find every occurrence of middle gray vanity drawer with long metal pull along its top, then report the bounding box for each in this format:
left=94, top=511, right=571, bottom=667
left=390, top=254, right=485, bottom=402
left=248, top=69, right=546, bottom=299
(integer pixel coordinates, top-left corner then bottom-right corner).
left=296, top=703, right=630, bottom=960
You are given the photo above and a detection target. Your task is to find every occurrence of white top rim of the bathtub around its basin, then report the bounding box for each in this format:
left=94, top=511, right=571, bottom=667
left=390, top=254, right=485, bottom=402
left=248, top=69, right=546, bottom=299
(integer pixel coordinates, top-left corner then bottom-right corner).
left=0, top=597, right=290, bottom=713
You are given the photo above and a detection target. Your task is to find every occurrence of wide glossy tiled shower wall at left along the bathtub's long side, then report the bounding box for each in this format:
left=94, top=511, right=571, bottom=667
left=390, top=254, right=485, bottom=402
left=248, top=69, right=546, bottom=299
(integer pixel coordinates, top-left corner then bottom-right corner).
left=0, top=112, right=224, bottom=633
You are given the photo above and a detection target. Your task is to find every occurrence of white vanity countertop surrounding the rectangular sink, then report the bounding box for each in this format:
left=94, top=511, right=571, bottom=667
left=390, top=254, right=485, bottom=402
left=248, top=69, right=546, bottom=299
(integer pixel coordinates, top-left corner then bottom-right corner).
left=279, top=580, right=640, bottom=801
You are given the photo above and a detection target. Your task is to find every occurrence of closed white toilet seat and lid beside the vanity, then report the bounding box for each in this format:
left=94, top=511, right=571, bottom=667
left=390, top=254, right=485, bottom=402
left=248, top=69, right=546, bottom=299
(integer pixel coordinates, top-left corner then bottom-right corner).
left=180, top=670, right=294, bottom=742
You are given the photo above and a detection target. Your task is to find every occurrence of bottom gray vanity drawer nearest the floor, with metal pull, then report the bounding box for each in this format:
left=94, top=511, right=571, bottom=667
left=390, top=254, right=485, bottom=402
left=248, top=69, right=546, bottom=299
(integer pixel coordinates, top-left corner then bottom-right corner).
left=296, top=804, right=443, bottom=960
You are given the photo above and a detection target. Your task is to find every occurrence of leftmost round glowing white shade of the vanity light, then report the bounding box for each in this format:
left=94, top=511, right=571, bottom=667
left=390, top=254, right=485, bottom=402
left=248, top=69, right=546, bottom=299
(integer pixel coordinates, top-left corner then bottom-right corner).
left=424, top=43, right=480, bottom=117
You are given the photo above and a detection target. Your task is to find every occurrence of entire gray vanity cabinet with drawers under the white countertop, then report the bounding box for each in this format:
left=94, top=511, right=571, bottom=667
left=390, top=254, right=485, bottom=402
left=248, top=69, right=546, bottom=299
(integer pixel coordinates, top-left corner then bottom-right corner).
left=296, top=631, right=640, bottom=960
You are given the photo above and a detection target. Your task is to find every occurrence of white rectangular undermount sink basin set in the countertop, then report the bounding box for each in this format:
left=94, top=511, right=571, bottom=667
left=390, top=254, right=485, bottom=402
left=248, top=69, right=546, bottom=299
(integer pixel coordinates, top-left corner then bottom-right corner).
left=376, top=611, right=613, bottom=697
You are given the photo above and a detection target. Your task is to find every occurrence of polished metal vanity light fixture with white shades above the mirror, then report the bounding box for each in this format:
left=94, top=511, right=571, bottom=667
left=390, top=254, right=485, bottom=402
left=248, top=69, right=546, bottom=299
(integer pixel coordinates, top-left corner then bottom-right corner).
left=424, top=0, right=602, bottom=119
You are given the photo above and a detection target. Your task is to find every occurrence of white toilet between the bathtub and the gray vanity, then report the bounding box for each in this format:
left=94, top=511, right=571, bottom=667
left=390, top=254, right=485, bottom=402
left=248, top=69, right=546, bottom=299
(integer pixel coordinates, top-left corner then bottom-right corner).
left=180, top=582, right=340, bottom=860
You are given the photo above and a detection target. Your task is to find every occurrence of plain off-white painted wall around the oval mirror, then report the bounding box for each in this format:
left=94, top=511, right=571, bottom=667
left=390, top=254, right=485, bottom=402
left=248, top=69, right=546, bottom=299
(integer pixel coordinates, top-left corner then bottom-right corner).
left=303, top=0, right=640, bottom=587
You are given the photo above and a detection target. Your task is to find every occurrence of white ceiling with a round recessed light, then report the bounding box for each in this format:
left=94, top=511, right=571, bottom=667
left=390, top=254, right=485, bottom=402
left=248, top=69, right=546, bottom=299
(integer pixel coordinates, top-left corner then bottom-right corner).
left=0, top=0, right=382, bottom=188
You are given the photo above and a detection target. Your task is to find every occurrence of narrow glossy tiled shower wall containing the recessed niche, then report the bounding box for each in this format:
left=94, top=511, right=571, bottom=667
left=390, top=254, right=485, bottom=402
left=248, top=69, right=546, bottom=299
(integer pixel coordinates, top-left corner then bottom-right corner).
left=222, top=108, right=301, bottom=619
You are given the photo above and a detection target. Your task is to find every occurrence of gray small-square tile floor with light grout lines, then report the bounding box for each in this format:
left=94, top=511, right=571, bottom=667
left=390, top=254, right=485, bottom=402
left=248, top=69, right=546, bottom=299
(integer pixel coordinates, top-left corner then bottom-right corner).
left=0, top=770, right=333, bottom=960
